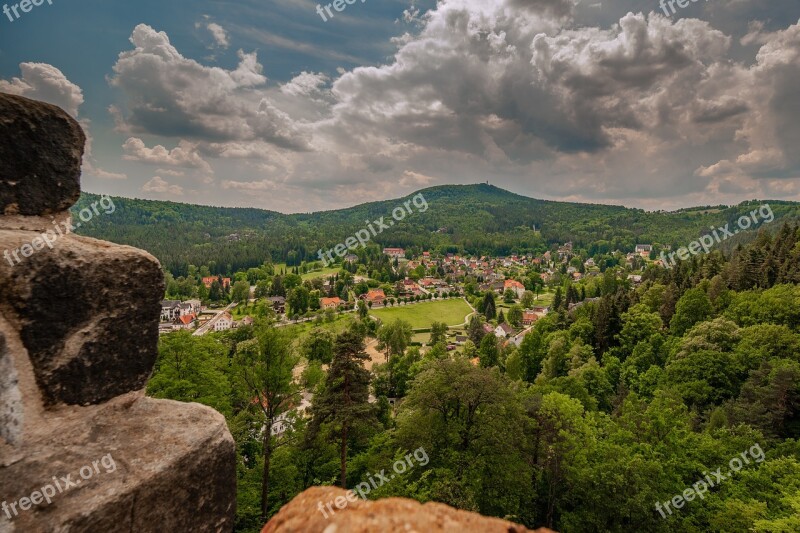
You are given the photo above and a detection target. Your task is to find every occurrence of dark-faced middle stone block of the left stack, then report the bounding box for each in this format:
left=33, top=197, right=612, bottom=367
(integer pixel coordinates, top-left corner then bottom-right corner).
left=0, top=230, right=164, bottom=405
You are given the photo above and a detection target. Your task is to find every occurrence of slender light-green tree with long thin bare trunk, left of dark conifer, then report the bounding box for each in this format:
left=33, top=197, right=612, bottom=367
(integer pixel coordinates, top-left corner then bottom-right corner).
left=233, top=325, right=299, bottom=520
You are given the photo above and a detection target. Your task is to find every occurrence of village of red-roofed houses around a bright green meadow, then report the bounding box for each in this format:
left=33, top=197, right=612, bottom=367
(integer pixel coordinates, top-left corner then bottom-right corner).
left=160, top=242, right=661, bottom=350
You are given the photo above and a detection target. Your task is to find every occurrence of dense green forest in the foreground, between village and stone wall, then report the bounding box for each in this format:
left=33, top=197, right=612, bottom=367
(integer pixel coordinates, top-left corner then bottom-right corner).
left=147, top=219, right=800, bottom=533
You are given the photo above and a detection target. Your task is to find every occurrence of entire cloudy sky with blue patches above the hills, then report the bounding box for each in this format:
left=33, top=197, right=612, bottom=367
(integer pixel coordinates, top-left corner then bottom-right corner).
left=0, top=0, right=800, bottom=213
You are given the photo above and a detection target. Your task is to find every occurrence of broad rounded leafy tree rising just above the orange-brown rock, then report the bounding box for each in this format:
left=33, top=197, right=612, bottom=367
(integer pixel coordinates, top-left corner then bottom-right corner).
left=397, top=358, right=530, bottom=516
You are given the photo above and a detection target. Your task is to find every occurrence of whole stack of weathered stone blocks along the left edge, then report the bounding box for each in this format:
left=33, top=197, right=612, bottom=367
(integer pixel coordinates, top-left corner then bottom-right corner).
left=0, top=94, right=236, bottom=533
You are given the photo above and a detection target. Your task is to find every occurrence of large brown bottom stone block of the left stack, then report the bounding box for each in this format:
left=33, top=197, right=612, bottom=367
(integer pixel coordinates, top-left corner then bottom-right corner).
left=0, top=393, right=236, bottom=533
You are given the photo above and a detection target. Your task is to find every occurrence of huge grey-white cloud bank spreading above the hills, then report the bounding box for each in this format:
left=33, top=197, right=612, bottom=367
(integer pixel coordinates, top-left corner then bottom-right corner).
left=6, top=5, right=800, bottom=211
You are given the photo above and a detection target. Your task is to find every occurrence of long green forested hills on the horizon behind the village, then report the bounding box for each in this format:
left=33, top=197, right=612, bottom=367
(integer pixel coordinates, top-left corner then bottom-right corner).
left=73, top=184, right=800, bottom=275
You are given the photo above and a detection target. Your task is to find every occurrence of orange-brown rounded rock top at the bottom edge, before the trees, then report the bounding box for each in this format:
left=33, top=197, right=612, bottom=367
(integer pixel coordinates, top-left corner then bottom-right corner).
left=261, top=487, right=547, bottom=533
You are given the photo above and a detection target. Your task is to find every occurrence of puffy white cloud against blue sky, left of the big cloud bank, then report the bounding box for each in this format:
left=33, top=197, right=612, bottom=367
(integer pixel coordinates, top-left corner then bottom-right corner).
left=110, top=24, right=308, bottom=150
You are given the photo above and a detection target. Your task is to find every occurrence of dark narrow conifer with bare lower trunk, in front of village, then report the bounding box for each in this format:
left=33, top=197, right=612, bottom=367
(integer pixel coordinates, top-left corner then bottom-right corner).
left=311, top=330, right=378, bottom=489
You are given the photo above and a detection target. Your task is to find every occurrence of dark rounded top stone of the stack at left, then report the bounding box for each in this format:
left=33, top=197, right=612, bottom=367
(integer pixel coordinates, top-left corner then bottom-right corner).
left=0, top=93, right=86, bottom=215
